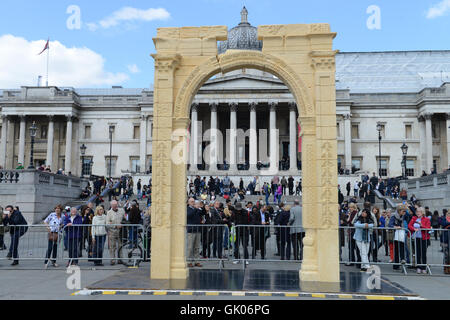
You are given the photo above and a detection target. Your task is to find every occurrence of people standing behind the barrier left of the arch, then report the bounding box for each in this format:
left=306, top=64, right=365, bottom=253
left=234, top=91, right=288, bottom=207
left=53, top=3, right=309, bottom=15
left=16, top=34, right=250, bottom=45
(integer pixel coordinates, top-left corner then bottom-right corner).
left=0, top=200, right=151, bottom=267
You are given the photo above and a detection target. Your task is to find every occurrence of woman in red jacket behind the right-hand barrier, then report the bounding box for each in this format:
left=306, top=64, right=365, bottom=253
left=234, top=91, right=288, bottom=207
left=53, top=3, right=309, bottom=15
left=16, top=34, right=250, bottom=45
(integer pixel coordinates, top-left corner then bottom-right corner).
left=408, top=207, right=431, bottom=274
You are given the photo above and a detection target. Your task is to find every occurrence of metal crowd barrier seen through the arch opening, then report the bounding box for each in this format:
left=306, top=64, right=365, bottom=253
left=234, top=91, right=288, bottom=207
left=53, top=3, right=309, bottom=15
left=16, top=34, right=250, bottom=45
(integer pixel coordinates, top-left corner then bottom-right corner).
left=186, top=224, right=304, bottom=268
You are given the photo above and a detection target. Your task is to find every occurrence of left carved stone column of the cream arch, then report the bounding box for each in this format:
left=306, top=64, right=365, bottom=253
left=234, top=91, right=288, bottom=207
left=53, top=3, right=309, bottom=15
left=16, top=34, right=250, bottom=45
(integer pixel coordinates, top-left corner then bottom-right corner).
left=151, top=54, right=187, bottom=279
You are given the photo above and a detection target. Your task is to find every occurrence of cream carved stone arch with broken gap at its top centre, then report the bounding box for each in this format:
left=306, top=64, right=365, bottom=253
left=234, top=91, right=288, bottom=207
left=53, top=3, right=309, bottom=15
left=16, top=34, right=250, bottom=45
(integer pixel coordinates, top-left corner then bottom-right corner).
left=151, top=24, right=339, bottom=283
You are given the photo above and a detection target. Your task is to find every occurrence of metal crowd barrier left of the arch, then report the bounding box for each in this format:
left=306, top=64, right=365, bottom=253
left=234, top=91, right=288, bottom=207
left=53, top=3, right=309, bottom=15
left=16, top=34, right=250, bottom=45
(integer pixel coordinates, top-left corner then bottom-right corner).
left=0, top=224, right=151, bottom=267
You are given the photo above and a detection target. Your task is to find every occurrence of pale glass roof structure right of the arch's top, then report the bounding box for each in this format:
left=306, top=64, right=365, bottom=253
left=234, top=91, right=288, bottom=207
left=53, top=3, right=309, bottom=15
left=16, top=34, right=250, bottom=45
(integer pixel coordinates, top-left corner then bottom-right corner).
left=336, top=51, right=450, bottom=93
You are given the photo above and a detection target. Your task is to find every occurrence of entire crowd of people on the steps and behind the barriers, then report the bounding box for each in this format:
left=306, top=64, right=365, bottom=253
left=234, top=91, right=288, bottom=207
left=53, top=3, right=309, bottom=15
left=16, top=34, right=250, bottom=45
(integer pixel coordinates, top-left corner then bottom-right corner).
left=0, top=170, right=450, bottom=274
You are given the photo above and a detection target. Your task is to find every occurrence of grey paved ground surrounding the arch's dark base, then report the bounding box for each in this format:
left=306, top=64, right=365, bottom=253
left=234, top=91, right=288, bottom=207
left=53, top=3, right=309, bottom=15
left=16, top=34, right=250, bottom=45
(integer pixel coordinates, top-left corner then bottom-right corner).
left=0, top=260, right=450, bottom=300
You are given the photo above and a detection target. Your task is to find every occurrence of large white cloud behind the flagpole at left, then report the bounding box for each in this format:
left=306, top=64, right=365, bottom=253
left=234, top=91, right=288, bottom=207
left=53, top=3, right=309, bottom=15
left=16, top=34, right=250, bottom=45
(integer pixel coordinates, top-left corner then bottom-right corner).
left=0, top=34, right=129, bottom=88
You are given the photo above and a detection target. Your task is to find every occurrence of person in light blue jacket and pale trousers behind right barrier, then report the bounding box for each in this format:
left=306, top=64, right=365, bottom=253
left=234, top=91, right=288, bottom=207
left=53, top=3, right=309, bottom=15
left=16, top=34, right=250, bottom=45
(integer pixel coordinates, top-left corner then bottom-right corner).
left=353, top=209, right=374, bottom=271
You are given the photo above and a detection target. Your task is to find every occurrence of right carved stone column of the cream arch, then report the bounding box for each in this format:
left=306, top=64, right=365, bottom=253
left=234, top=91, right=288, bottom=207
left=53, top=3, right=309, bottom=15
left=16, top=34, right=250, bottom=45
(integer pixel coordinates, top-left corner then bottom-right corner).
left=300, top=50, right=340, bottom=290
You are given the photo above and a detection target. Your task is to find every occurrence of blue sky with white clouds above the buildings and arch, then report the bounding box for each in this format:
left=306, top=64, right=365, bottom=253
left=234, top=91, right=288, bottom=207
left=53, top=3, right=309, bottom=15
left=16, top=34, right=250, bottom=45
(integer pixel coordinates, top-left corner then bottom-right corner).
left=0, top=0, right=450, bottom=89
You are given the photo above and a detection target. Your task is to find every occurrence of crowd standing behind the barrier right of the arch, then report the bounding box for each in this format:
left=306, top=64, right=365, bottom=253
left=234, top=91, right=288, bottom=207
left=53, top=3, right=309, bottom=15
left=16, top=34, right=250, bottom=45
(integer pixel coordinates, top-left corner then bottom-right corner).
left=339, top=199, right=450, bottom=274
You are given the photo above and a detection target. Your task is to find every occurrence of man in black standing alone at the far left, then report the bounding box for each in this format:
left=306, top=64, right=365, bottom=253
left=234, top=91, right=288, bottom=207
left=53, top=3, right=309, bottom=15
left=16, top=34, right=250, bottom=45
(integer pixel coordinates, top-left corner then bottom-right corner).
left=3, top=206, right=28, bottom=266
